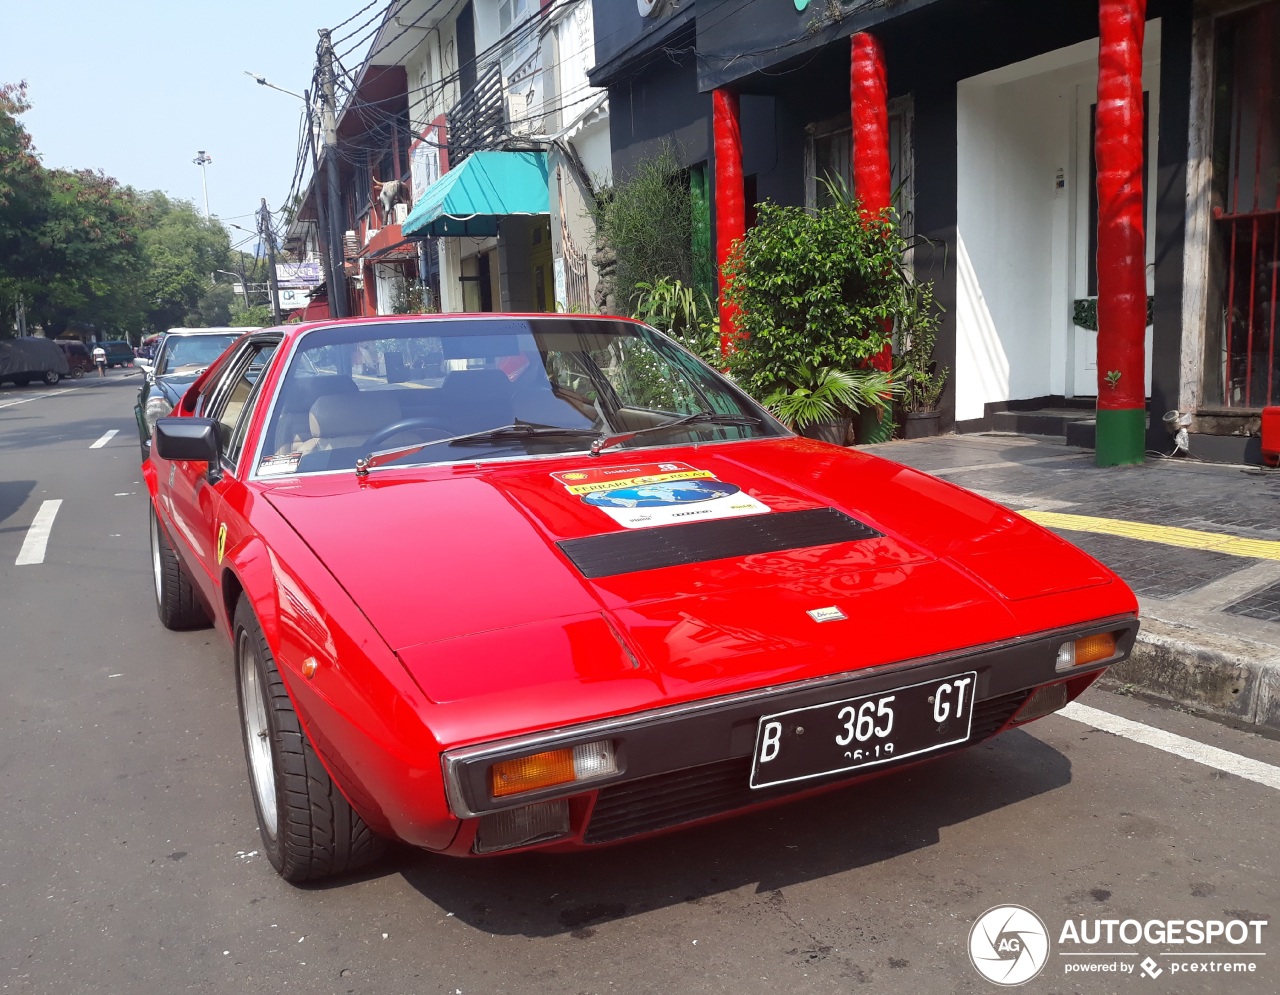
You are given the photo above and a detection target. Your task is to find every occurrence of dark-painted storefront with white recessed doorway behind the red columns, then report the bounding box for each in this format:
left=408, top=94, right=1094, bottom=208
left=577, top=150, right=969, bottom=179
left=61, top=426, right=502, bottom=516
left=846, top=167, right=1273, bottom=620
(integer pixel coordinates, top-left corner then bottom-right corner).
left=593, top=0, right=1280, bottom=458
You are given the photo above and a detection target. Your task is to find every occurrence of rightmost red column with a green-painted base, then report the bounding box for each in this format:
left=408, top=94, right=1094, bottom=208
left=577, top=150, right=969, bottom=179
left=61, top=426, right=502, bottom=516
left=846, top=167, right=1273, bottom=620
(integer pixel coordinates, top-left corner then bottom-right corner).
left=1094, top=0, right=1147, bottom=466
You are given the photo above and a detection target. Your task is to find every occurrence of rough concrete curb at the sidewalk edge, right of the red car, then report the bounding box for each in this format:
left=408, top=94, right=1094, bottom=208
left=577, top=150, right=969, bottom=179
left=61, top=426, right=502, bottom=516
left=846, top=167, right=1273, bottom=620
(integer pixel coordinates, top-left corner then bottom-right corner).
left=1101, top=617, right=1280, bottom=734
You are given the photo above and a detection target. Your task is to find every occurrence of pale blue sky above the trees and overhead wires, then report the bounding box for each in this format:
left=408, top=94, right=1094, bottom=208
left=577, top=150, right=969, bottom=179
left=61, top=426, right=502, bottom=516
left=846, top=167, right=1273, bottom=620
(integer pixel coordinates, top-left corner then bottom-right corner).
left=0, top=0, right=385, bottom=243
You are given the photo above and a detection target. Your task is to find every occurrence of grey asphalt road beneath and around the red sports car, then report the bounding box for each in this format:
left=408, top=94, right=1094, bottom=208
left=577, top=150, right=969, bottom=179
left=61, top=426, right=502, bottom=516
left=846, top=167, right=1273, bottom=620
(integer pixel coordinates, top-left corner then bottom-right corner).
left=0, top=371, right=1280, bottom=995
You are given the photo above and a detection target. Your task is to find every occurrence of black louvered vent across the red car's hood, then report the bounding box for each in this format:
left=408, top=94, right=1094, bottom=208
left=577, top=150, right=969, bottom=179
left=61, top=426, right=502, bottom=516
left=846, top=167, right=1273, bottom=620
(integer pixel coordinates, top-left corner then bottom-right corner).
left=557, top=508, right=882, bottom=579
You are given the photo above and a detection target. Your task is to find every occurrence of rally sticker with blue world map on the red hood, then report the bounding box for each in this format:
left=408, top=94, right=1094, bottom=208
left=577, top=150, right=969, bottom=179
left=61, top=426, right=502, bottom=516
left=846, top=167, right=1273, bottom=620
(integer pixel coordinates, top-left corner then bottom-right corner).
left=552, top=464, right=772, bottom=529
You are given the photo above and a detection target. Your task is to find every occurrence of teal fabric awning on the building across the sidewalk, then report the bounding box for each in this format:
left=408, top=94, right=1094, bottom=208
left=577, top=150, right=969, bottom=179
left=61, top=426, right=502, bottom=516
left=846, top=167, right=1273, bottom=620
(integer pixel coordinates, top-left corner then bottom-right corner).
left=401, top=152, right=550, bottom=238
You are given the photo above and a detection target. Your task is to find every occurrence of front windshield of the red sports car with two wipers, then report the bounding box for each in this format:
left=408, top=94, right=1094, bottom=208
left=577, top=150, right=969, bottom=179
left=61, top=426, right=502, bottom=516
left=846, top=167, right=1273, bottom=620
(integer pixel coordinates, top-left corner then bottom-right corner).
left=257, top=316, right=783, bottom=475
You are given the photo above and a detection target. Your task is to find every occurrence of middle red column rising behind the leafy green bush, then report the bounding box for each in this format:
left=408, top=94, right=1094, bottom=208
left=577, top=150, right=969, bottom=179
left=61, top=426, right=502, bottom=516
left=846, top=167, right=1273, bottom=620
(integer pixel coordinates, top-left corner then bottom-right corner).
left=849, top=32, right=893, bottom=370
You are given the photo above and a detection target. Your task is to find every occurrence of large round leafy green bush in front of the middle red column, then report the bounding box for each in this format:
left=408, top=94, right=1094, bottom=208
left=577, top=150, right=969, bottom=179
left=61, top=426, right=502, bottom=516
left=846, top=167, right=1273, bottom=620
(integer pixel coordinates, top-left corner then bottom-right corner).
left=722, top=177, right=904, bottom=442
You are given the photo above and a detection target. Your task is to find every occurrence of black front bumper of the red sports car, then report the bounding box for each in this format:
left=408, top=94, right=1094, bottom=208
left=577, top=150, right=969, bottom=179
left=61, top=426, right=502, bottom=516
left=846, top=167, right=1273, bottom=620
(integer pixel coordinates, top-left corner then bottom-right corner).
left=443, top=616, right=1138, bottom=852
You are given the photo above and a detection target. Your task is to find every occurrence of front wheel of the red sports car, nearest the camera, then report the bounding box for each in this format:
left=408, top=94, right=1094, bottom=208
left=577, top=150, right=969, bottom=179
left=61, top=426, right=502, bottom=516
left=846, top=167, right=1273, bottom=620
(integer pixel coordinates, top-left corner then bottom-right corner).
left=232, top=598, right=387, bottom=884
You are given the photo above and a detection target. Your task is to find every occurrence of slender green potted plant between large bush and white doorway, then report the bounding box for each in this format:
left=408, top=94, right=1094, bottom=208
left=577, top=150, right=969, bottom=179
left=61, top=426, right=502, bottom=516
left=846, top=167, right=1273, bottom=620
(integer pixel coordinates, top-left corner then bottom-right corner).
left=893, top=279, right=948, bottom=439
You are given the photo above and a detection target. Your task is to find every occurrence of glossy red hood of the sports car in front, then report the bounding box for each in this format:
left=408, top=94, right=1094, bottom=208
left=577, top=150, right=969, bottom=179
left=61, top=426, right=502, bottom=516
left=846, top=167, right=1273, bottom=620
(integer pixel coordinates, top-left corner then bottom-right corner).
left=264, top=438, right=1137, bottom=717
